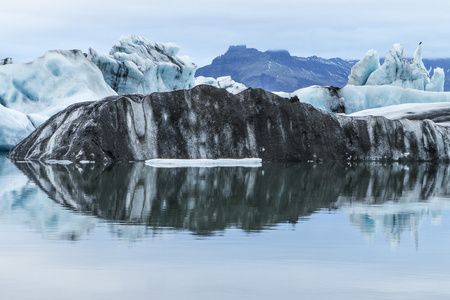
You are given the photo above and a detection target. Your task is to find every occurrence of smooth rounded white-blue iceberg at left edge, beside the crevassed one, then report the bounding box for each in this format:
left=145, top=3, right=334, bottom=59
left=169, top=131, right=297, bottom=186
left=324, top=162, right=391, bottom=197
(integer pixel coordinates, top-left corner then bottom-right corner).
left=0, top=50, right=116, bottom=117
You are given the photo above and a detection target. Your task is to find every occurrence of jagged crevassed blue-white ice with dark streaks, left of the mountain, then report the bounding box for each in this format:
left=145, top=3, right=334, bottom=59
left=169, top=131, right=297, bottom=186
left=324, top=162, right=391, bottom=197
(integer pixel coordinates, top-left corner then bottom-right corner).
left=88, top=35, right=197, bottom=95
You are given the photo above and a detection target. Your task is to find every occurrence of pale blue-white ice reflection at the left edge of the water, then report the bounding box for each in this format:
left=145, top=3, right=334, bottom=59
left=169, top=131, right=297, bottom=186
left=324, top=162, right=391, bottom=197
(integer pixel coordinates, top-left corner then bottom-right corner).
left=0, top=156, right=97, bottom=240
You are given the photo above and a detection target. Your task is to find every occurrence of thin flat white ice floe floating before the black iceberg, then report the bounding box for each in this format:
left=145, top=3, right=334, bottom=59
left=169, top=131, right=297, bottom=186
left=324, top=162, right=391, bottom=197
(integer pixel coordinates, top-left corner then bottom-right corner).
left=145, top=158, right=262, bottom=168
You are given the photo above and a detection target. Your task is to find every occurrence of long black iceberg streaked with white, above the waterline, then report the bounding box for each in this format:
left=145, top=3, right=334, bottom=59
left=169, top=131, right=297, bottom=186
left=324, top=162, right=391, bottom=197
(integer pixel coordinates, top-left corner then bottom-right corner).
left=8, top=85, right=450, bottom=161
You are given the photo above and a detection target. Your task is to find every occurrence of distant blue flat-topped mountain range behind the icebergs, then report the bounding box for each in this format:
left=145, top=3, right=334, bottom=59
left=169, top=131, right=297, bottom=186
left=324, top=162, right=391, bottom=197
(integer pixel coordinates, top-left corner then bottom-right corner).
left=199, top=45, right=450, bottom=92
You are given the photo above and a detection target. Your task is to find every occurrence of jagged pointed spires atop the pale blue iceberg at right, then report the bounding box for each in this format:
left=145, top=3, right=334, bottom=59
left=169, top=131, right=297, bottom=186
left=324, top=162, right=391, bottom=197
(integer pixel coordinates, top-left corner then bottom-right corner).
left=347, top=44, right=445, bottom=92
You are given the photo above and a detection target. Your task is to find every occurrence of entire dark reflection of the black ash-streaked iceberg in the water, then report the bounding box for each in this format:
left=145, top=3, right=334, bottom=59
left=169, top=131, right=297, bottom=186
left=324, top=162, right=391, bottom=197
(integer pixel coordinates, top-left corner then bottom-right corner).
left=13, top=162, right=449, bottom=238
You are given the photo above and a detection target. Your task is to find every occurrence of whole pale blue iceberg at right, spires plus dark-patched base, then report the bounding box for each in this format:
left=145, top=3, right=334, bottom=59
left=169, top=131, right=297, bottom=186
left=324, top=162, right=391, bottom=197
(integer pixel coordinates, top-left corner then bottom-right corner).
left=276, top=44, right=450, bottom=114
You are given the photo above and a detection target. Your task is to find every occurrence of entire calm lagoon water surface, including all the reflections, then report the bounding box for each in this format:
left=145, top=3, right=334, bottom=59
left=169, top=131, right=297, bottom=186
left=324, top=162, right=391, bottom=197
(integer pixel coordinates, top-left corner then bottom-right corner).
left=0, top=155, right=450, bottom=299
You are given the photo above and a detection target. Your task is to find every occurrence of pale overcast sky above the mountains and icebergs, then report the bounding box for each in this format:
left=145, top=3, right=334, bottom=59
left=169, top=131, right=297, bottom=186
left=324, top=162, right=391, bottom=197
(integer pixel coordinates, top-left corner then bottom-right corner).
left=0, top=0, right=450, bottom=66
